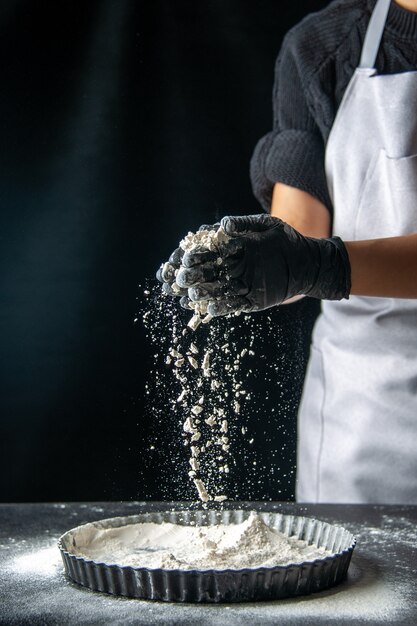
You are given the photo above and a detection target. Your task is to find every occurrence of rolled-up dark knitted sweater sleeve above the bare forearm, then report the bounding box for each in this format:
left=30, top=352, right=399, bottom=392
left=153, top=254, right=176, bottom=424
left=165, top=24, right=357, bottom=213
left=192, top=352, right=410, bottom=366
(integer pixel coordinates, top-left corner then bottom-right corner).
left=250, top=31, right=331, bottom=211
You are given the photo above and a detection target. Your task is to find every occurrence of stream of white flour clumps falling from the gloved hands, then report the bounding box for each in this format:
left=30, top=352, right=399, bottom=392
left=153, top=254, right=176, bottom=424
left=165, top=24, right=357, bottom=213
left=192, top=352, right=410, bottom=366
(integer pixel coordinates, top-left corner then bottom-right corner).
left=158, top=228, right=248, bottom=502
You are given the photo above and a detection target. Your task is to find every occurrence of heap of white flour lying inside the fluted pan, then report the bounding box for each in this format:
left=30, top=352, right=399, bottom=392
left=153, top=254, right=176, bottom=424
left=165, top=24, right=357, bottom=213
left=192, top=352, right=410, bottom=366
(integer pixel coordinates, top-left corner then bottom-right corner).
left=75, top=513, right=331, bottom=569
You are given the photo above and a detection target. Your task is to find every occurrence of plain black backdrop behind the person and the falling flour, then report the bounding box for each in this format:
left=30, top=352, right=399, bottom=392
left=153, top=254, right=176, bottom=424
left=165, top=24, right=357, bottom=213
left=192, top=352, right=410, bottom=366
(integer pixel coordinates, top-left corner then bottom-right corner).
left=0, top=0, right=328, bottom=502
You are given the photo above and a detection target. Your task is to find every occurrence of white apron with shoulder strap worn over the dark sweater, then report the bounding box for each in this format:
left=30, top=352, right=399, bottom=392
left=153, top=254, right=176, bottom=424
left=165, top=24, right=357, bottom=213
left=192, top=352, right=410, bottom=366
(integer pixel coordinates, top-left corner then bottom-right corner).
left=297, top=0, right=417, bottom=504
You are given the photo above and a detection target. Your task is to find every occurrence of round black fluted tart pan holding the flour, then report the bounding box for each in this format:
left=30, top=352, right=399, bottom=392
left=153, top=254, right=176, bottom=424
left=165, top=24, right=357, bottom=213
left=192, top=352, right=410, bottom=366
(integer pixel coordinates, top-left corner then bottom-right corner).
left=58, top=510, right=356, bottom=603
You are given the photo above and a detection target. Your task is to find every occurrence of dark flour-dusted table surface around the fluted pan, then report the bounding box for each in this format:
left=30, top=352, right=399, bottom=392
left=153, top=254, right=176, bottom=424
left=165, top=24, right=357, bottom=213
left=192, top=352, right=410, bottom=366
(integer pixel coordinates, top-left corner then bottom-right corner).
left=0, top=502, right=417, bottom=626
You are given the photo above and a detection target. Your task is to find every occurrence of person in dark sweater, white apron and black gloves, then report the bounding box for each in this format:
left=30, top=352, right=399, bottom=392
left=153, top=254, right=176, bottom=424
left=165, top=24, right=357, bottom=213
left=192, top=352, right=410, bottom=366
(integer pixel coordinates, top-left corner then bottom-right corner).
left=159, top=0, right=417, bottom=504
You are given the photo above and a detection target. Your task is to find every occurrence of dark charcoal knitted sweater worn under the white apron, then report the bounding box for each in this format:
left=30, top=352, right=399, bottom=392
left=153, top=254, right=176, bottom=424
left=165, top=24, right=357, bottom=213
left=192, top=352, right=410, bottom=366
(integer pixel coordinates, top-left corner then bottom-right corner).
left=251, top=0, right=417, bottom=211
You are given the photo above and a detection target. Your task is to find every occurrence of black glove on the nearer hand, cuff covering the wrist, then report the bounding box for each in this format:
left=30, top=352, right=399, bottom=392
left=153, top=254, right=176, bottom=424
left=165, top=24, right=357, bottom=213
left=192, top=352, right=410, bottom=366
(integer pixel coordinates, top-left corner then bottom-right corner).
left=176, top=214, right=350, bottom=315
